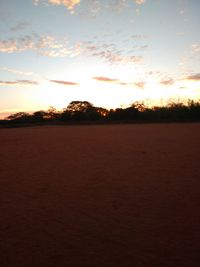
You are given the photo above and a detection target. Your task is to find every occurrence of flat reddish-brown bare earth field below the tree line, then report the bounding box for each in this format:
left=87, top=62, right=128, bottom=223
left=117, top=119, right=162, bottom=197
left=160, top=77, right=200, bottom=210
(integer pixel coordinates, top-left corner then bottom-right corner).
left=0, top=123, right=200, bottom=267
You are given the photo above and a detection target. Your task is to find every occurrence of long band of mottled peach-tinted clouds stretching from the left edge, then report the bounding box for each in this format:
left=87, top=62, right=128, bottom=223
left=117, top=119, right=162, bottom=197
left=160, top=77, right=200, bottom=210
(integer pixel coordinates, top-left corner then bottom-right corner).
left=0, top=33, right=144, bottom=65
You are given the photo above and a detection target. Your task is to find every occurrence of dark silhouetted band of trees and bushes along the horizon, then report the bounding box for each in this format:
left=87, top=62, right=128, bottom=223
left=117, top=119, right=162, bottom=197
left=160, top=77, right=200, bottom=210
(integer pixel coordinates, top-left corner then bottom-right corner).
left=0, top=100, right=200, bottom=127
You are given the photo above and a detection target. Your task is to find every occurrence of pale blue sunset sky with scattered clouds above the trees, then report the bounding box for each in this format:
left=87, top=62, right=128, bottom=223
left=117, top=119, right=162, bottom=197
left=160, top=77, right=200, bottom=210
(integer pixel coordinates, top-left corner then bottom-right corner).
left=0, top=0, right=200, bottom=117
